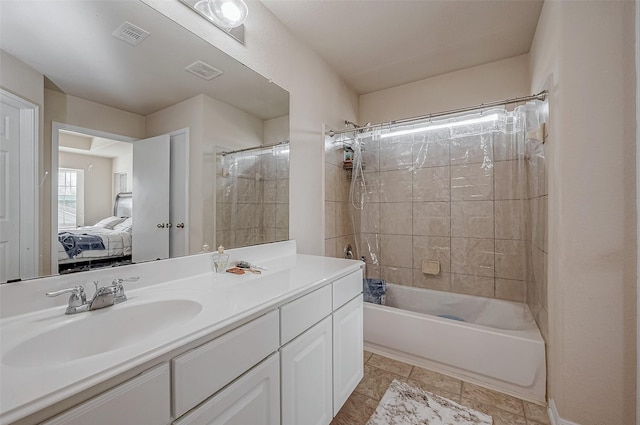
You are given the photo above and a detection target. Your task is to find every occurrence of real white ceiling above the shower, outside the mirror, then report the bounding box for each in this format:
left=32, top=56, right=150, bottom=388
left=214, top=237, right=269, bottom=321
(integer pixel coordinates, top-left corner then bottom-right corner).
left=262, top=0, right=542, bottom=94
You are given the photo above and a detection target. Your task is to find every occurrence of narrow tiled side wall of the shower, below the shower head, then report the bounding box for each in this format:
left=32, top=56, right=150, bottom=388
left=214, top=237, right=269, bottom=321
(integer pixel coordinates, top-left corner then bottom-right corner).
left=324, top=137, right=360, bottom=258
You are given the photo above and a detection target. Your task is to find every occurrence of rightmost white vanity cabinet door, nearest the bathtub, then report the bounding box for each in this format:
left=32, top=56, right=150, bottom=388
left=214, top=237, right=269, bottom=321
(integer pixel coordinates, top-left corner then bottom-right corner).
left=333, top=294, right=363, bottom=415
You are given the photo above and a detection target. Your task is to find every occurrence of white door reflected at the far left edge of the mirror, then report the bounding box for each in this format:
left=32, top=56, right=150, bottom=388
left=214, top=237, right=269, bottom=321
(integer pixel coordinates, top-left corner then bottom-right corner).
left=0, top=97, right=20, bottom=282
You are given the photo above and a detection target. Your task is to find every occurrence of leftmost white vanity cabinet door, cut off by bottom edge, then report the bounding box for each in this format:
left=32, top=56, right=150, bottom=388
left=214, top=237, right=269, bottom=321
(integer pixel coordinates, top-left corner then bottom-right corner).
left=174, top=353, right=280, bottom=425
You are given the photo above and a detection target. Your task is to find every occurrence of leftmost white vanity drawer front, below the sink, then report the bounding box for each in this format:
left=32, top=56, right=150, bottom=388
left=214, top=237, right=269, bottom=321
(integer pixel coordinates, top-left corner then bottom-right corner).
left=43, top=363, right=171, bottom=425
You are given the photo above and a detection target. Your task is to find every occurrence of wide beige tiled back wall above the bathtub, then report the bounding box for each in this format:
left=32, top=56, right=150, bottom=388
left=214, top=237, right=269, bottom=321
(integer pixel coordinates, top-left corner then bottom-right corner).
left=356, top=133, right=526, bottom=301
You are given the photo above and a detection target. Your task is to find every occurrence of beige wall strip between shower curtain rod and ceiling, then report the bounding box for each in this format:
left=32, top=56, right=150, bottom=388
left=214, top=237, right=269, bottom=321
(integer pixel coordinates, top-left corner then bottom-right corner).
left=358, top=55, right=531, bottom=125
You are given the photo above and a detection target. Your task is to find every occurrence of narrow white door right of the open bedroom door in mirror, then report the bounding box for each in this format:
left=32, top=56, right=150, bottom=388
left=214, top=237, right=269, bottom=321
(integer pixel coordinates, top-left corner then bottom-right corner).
left=169, top=129, right=189, bottom=258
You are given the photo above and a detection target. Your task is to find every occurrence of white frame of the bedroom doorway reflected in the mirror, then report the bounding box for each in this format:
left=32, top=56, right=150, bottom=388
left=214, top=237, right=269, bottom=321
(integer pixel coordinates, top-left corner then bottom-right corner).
left=50, top=121, right=139, bottom=275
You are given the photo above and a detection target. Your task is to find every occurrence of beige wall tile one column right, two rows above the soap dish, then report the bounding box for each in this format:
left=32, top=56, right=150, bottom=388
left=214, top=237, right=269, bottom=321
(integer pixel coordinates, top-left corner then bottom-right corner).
left=451, top=163, right=493, bottom=201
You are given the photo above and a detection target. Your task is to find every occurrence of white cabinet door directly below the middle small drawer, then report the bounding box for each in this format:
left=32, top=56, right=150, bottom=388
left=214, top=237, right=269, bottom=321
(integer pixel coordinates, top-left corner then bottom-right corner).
left=280, top=316, right=333, bottom=425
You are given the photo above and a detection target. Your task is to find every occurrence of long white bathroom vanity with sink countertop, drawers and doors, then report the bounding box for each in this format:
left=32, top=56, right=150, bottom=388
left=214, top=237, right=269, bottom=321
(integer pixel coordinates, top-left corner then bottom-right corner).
left=0, top=241, right=363, bottom=425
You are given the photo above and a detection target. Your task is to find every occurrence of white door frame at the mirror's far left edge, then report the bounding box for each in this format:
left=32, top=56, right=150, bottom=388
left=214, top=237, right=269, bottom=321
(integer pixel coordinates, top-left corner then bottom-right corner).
left=0, top=88, right=38, bottom=280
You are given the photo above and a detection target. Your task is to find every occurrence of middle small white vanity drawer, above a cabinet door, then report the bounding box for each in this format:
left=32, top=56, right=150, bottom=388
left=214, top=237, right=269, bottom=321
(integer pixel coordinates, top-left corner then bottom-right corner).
left=280, top=285, right=331, bottom=345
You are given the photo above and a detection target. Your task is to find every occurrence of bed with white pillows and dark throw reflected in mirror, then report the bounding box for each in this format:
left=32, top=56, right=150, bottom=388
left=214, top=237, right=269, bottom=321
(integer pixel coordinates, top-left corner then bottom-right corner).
left=58, top=192, right=133, bottom=274
